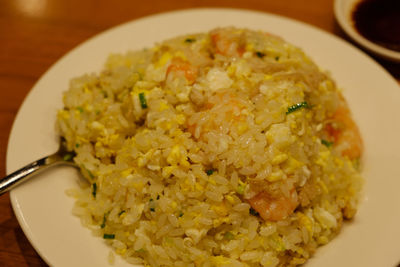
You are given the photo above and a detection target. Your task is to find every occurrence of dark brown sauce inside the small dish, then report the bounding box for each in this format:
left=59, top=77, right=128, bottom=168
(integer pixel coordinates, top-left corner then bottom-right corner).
left=352, top=0, right=400, bottom=52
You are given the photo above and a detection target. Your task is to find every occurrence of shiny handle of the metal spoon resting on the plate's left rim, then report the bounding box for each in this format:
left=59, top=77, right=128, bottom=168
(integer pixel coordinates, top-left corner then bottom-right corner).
left=0, top=153, right=65, bottom=195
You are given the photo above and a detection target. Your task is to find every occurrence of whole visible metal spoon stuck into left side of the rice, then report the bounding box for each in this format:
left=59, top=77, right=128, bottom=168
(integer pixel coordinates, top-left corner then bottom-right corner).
left=0, top=138, right=78, bottom=195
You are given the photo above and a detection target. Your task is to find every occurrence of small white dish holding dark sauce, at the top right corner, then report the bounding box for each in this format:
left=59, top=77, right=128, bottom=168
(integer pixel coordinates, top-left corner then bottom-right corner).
left=334, top=0, right=400, bottom=62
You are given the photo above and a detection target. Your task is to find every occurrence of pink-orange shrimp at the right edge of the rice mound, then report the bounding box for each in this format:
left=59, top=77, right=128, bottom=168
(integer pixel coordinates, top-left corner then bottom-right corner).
left=326, top=96, right=363, bottom=160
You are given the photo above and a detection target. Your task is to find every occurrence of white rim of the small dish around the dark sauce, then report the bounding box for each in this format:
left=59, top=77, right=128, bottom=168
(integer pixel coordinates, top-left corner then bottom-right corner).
left=334, top=0, right=400, bottom=62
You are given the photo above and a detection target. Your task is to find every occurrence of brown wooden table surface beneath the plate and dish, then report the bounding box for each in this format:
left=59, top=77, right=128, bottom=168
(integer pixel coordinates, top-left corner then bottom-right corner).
left=0, top=0, right=400, bottom=266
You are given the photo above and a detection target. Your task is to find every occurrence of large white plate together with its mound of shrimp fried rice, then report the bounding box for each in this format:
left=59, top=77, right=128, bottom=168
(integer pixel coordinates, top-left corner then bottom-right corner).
left=7, top=9, right=400, bottom=266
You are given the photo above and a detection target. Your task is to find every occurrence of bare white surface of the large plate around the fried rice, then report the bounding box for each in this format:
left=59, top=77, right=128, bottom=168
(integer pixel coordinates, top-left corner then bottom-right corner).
left=7, top=9, right=400, bottom=267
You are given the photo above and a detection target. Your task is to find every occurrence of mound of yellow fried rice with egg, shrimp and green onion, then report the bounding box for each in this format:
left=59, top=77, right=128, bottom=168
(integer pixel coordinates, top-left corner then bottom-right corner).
left=57, top=28, right=362, bottom=266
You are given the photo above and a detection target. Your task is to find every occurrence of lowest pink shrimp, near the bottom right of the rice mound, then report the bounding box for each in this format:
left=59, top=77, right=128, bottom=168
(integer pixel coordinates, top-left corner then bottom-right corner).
left=248, top=189, right=299, bottom=221
